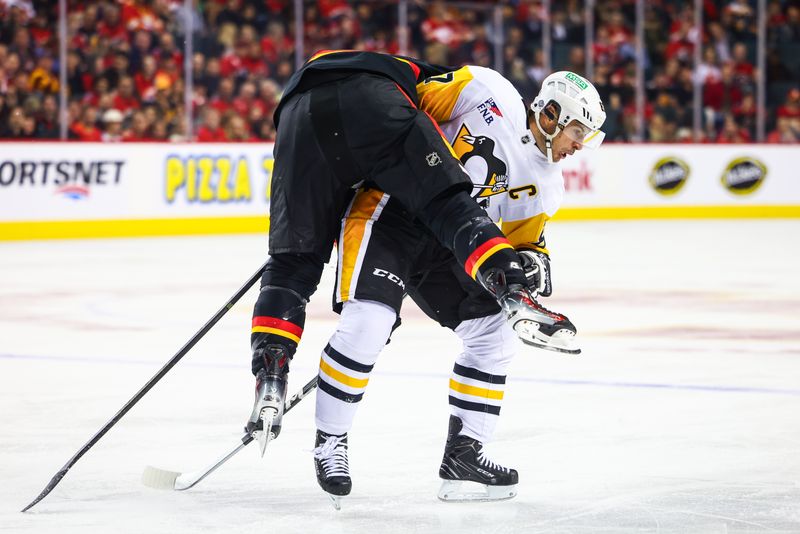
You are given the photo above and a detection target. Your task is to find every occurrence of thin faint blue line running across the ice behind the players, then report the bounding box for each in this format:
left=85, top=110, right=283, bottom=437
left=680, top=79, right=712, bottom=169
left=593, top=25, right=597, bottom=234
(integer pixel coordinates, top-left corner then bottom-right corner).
left=6, top=353, right=800, bottom=397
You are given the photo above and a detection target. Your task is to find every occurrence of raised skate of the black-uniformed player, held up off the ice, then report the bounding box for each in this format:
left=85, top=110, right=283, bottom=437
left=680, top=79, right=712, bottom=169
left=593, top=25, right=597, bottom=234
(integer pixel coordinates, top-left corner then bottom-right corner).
left=500, top=286, right=581, bottom=354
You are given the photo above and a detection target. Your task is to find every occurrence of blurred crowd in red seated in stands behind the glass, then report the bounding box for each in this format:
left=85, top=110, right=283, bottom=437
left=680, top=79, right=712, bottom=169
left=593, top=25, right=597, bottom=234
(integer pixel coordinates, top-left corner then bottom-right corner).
left=0, top=0, right=800, bottom=143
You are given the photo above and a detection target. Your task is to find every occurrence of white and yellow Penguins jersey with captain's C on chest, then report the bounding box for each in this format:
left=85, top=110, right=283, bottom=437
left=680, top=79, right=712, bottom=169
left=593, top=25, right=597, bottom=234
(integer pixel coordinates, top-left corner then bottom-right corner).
left=417, top=66, right=564, bottom=251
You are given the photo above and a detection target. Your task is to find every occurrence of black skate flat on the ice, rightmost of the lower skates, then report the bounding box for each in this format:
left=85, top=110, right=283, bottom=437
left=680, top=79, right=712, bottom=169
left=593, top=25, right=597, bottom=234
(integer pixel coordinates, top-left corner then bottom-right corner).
left=439, top=415, right=519, bottom=502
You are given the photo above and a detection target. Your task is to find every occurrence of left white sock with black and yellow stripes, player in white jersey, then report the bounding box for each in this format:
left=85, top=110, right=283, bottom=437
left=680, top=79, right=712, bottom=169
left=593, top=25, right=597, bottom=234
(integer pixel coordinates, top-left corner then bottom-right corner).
left=316, top=300, right=397, bottom=435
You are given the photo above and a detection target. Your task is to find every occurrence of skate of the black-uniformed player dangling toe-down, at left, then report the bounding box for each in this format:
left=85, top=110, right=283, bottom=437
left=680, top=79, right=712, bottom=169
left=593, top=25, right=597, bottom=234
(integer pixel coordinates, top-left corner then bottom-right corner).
left=245, top=345, right=290, bottom=456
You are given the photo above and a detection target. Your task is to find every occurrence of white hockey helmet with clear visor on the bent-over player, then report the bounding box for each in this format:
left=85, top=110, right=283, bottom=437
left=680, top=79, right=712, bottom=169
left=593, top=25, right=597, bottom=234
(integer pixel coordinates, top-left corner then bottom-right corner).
left=531, top=70, right=606, bottom=163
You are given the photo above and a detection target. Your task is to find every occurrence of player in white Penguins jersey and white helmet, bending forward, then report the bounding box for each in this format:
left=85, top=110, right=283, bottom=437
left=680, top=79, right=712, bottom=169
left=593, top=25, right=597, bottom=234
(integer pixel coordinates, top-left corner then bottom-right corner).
left=314, top=66, right=605, bottom=508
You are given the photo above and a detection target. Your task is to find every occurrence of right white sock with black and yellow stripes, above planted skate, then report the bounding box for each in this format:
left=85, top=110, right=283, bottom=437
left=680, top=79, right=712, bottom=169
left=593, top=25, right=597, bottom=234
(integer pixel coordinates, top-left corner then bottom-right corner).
left=449, top=313, right=517, bottom=443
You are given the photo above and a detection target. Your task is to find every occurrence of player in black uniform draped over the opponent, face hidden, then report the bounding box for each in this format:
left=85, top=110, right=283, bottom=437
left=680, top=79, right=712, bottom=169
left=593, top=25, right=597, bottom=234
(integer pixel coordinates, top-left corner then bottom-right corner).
left=247, top=51, right=536, bottom=452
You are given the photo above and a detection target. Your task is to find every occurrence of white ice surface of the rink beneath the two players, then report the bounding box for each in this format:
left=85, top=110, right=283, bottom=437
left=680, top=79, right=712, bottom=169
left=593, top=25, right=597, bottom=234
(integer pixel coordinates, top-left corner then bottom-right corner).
left=0, top=221, right=800, bottom=534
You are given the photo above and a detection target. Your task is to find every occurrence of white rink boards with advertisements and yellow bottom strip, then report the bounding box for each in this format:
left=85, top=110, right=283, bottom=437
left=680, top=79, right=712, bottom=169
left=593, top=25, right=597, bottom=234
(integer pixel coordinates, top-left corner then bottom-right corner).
left=0, top=143, right=800, bottom=240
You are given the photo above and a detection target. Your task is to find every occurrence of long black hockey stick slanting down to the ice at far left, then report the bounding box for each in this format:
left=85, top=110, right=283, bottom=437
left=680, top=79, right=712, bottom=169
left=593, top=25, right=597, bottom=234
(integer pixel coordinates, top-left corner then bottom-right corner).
left=22, top=263, right=267, bottom=512
